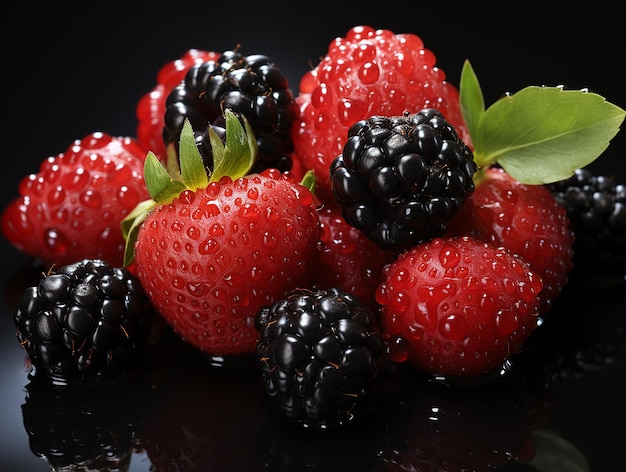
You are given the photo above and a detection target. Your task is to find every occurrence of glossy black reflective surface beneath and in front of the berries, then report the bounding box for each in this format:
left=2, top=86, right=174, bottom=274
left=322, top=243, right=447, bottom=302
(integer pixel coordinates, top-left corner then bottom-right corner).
left=0, top=261, right=626, bottom=472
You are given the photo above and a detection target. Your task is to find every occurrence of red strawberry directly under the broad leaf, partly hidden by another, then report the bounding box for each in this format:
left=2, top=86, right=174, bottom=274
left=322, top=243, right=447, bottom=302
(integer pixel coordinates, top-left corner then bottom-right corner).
left=448, top=167, right=574, bottom=313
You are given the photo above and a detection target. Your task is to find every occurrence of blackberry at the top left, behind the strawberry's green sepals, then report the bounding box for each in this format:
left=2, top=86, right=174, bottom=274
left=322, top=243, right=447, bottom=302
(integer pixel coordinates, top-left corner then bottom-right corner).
left=163, top=50, right=295, bottom=172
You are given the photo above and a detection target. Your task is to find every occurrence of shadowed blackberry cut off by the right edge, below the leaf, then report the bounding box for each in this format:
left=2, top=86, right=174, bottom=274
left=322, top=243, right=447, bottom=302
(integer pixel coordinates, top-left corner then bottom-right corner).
left=547, top=168, right=626, bottom=281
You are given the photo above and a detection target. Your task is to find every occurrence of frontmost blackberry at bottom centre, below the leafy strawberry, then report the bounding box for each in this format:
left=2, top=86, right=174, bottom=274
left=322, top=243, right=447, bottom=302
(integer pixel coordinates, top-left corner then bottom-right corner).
left=256, top=288, right=388, bottom=429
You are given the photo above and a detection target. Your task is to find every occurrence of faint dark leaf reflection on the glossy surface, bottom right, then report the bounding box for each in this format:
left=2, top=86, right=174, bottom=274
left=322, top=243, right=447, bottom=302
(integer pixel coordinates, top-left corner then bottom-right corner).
left=527, top=430, right=590, bottom=472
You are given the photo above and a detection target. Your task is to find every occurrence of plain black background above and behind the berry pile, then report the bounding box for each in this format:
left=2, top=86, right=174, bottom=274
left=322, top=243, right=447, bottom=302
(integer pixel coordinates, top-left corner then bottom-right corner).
left=0, top=0, right=626, bottom=470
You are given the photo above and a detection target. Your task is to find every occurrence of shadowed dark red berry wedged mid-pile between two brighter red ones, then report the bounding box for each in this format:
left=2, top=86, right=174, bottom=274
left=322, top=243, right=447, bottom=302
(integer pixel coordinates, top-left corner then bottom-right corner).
left=314, top=205, right=394, bottom=307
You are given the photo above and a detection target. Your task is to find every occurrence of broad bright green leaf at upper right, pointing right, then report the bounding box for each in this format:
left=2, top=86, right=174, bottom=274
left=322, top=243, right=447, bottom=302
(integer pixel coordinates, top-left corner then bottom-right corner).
left=466, top=86, right=625, bottom=184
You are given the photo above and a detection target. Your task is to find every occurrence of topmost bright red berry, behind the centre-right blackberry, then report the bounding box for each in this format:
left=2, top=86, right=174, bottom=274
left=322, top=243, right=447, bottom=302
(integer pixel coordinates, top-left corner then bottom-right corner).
left=292, top=26, right=471, bottom=200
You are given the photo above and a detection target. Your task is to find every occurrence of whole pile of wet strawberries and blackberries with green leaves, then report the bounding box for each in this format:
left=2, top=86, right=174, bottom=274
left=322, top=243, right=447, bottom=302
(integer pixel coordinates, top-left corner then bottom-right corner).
left=2, top=26, right=626, bottom=438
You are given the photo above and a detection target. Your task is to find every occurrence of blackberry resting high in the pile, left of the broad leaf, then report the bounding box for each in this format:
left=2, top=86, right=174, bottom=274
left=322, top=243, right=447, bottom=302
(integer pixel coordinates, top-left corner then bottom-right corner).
left=330, top=108, right=477, bottom=251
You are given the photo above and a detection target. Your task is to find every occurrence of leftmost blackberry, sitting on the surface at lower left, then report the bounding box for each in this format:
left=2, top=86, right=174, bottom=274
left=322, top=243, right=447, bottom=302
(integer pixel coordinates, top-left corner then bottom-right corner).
left=14, top=259, right=153, bottom=384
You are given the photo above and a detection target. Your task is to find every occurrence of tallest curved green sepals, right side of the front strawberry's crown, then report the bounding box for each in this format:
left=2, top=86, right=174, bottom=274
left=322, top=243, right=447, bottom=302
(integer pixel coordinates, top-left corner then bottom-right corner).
left=209, top=109, right=258, bottom=182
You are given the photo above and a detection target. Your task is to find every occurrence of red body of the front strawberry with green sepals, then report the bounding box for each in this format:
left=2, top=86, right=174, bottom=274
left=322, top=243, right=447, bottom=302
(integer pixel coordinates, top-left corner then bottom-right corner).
left=135, top=169, right=320, bottom=356
